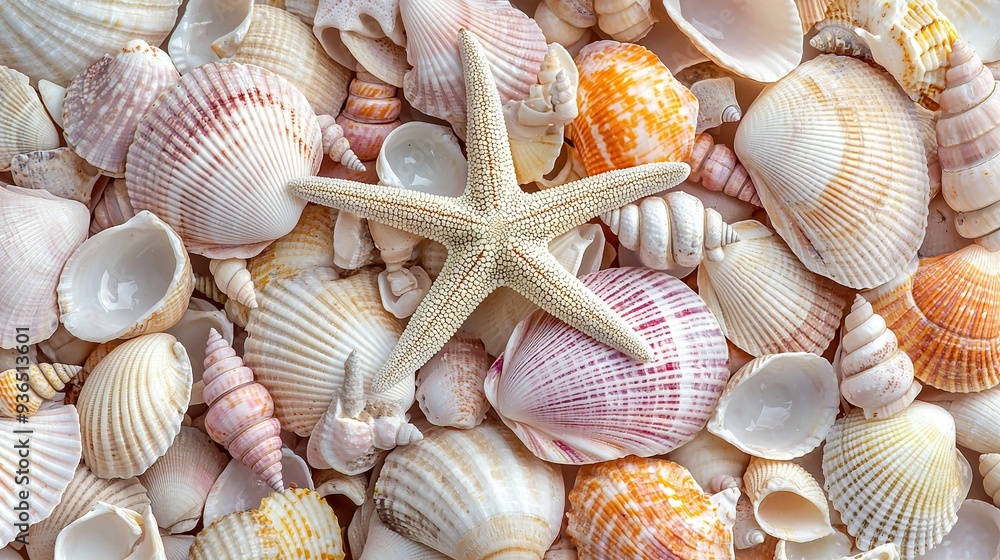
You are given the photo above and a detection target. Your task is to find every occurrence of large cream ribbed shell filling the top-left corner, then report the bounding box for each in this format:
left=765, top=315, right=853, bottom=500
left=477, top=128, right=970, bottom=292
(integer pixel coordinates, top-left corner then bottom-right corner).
left=0, top=0, right=181, bottom=86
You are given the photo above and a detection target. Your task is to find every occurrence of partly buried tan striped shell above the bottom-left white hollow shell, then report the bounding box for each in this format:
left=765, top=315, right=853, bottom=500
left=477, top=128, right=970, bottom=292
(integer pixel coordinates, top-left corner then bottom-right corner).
left=27, top=464, right=150, bottom=560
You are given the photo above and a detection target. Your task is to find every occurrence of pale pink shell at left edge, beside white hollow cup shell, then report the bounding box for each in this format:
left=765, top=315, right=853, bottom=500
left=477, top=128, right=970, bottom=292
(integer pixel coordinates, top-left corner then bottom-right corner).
left=0, top=183, right=89, bottom=348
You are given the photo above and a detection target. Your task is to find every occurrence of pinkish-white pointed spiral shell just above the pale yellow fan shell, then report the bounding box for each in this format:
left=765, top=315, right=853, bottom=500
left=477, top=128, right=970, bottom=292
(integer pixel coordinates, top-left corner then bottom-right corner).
left=840, top=295, right=921, bottom=418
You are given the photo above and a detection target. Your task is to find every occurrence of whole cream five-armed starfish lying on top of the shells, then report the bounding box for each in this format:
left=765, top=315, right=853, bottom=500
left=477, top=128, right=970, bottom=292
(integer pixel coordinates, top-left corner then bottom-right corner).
left=289, top=29, right=690, bottom=391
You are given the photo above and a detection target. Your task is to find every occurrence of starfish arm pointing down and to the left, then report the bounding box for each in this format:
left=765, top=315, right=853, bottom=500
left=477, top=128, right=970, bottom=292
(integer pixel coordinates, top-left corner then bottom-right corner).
left=372, top=247, right=499, bottom=392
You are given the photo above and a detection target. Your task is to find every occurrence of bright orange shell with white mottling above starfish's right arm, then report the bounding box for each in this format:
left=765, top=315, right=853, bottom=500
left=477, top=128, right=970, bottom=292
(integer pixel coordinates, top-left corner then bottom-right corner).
left=573, top=41, right=698, bottom=175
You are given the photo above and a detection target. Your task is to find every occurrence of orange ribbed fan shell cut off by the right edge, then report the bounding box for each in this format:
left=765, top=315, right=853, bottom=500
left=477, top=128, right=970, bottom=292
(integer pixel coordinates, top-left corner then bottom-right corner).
left=863, top=244, right=1000, bottom=393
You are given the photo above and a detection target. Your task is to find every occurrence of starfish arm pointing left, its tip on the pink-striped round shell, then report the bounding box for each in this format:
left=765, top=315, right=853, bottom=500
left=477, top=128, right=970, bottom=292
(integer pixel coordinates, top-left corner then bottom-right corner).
left=288, top=177, right=475, bottom=244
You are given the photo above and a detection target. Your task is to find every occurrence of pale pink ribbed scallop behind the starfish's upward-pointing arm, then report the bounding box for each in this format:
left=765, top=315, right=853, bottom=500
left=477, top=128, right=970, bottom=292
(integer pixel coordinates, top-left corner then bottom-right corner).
left=398, top=0, right=548, bottom=135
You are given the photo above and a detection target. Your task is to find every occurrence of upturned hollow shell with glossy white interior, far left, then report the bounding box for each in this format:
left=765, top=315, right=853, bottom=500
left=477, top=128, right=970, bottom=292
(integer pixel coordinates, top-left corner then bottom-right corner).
left=57, top=211, right=194, bottom=342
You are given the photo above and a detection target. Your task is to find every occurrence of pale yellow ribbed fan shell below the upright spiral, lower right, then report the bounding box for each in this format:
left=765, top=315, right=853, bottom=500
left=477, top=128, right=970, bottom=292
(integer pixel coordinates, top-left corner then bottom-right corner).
left=823, top=401, right=972, bottom=559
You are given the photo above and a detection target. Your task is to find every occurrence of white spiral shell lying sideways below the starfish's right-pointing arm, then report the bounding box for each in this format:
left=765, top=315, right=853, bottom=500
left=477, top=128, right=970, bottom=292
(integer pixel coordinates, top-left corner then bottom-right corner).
left=601, top=191, right=739, bottom=270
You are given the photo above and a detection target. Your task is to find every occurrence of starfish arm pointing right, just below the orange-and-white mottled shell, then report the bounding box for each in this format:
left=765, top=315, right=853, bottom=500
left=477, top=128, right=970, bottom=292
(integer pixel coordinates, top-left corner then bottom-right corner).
left=515, top=163, right=691, bottom=237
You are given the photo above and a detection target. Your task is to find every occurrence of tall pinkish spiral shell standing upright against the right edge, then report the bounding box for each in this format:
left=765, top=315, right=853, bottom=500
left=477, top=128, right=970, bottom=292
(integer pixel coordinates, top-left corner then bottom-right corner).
left=937, top=41, right=1000, bottom=251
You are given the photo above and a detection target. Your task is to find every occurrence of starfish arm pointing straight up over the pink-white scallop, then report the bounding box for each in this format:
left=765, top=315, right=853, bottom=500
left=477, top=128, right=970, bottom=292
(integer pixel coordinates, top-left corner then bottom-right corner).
left=458, top=29, right=521, bottom=209
